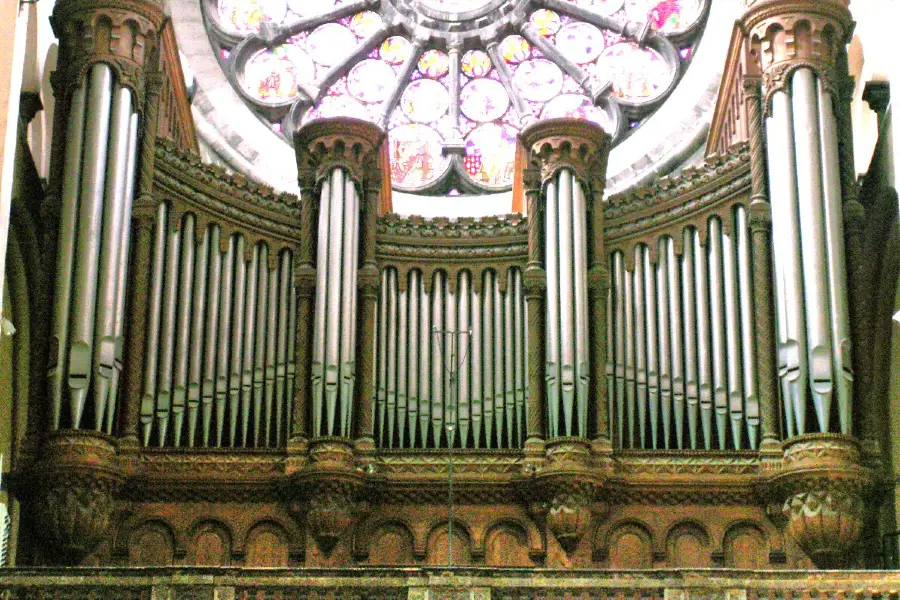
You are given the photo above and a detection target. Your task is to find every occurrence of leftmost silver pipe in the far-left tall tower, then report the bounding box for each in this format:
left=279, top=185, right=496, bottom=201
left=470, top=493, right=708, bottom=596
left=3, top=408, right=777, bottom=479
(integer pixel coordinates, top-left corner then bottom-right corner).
left=47, top=75, right=88, bottom=429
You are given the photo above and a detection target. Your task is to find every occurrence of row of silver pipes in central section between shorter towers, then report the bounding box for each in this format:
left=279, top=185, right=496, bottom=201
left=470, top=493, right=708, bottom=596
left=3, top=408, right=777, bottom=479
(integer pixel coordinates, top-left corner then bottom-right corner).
left=374, top=268, right=528, bottom=449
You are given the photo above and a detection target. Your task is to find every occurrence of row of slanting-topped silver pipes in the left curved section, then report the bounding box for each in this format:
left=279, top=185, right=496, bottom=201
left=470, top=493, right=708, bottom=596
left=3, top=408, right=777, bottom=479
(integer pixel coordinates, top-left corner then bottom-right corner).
left=141, top=213, right=296, bottom=447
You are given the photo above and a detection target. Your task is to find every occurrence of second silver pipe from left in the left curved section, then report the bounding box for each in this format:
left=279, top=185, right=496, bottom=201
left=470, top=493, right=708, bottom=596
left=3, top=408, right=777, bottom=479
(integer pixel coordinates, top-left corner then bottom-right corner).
left=156, top=229, right=181, bottom=447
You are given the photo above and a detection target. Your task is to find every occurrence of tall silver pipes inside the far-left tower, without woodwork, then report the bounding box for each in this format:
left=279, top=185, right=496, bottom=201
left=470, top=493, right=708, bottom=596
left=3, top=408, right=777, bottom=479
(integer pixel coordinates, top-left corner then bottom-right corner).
left=48, top=63, right=138, bottom=434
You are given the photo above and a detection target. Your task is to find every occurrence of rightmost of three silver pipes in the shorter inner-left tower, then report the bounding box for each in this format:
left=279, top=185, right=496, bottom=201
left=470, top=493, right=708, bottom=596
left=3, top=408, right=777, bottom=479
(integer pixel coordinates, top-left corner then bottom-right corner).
left=339, top=174, right=360, bottom=437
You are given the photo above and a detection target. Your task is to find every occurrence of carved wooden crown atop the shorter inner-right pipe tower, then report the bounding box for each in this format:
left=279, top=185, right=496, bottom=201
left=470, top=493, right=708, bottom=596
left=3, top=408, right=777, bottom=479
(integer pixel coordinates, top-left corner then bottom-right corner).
left=519, top=119, right=611, bottom=194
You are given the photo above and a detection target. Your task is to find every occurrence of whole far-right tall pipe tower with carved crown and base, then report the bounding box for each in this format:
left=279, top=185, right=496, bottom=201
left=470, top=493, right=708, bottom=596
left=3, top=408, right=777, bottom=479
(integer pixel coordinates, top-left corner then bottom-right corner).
left=742, top=0, right=873, bottom=568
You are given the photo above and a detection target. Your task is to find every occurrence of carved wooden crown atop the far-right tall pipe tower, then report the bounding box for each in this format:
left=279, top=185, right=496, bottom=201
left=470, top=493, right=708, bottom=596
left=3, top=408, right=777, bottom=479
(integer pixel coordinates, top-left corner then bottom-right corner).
left=742, top=0, right=853, bottom=112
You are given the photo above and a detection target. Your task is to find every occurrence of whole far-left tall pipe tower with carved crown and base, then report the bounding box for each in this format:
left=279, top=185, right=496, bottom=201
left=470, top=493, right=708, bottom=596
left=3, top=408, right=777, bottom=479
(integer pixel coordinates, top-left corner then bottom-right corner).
left=29, top=0, right=166, bottom=564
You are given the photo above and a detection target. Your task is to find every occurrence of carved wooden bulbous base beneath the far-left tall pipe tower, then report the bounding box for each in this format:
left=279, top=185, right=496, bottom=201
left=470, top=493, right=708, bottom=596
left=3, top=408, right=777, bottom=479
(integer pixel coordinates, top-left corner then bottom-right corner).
left=31, top=430, right=124, bottom=565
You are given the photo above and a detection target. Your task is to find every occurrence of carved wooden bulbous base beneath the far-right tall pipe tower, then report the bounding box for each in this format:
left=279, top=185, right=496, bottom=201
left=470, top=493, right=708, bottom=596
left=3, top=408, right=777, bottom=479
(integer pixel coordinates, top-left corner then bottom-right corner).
left=770, top=434, right=874, bottom=569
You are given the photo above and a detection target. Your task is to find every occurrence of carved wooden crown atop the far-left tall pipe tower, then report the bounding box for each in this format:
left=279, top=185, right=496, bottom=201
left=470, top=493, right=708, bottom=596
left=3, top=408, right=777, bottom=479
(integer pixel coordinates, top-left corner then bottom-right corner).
left=50, top=0, right=167, bottom=110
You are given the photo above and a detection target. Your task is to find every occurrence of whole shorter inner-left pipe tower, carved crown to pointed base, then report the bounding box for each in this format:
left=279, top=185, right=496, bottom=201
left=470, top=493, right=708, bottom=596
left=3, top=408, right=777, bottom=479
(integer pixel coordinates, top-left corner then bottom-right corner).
left=288, top=119, right=386, bottom=555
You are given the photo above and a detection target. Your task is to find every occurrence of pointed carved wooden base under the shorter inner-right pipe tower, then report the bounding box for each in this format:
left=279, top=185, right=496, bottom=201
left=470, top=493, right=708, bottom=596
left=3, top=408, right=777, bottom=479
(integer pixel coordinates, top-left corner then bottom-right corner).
left=521, top=438, right=608, bottom=554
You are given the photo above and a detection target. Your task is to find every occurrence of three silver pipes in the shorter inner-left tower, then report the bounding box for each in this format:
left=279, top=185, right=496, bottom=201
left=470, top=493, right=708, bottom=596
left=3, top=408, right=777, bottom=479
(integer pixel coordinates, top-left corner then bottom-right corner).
left=312, top=168, right=360, bottom=437
